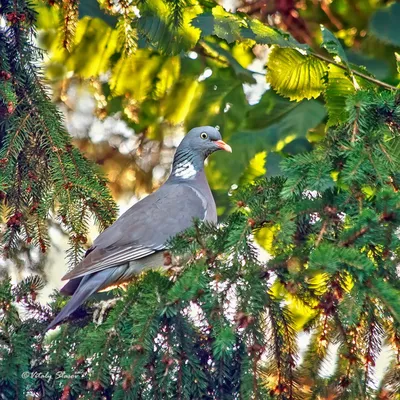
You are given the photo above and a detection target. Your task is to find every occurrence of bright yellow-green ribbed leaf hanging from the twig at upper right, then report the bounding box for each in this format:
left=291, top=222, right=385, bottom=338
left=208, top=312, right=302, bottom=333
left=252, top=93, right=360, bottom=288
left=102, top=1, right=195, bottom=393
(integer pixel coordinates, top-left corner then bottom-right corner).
left=267, top=47, right=327, bottom=101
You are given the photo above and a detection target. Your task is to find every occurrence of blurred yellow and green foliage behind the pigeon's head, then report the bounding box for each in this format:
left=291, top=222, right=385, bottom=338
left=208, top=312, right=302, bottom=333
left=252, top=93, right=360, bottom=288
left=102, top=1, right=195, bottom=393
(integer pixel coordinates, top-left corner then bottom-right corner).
left=36, top=0, right=400, bottom=214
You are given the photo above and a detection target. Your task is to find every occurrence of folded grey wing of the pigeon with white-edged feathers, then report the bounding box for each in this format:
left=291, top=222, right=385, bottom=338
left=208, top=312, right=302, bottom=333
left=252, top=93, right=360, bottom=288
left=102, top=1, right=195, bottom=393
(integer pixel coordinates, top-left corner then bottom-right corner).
left=63, top=184, right=207, bottom=279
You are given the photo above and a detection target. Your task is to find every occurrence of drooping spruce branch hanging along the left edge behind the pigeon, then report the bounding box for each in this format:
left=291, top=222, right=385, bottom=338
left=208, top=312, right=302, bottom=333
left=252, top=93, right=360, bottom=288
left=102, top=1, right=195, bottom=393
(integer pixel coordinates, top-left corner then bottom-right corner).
left=0, top=0, right=116, bottom=263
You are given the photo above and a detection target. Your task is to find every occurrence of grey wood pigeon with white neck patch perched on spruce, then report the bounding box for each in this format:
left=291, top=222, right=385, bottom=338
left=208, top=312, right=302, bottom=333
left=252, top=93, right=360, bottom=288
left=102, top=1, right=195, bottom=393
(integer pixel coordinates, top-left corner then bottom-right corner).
left=47, top=126, right=232, bottom=329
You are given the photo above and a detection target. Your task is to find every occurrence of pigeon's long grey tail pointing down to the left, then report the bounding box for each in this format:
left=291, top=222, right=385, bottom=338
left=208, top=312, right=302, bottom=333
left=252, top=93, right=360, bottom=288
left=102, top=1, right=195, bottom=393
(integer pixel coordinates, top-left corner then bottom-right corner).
left=46, top=268, right=114, bottom=331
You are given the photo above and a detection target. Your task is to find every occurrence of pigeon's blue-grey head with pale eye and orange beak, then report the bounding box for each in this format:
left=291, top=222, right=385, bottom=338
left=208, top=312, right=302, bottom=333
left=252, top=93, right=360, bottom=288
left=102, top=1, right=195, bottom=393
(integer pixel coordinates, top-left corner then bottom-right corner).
left=178, top=126, right=232, bottom=159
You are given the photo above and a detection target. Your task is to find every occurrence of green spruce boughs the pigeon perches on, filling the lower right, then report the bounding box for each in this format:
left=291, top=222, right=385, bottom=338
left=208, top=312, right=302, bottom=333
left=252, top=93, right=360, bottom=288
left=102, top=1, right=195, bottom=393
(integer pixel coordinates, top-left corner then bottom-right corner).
left=1, top=86, right=400, bottom=399
